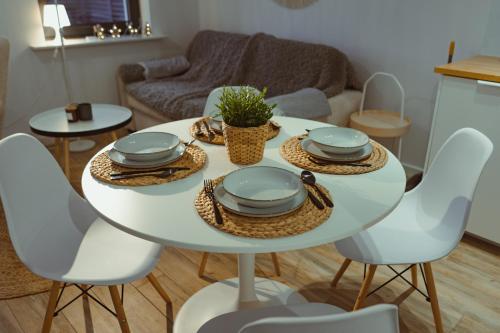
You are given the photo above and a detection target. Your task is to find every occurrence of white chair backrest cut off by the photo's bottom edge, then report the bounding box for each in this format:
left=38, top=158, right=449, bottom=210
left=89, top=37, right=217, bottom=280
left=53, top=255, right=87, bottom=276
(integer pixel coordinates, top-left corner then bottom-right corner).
left=239, top=304, right=399, bottom=333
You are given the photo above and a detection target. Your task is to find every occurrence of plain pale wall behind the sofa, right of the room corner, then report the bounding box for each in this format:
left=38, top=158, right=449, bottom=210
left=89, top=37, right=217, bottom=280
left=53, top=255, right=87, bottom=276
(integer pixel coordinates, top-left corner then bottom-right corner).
left=199, top=0, right=494, bottom=166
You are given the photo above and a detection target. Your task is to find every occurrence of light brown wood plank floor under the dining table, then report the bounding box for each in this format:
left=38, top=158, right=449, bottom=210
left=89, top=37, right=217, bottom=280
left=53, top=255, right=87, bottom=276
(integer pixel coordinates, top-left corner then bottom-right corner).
left=0, top=133, right=500, bottom=333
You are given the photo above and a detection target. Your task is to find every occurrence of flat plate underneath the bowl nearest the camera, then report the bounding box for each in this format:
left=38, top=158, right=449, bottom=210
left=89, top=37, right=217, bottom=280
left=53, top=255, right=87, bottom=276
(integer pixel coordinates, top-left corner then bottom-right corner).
left=214, top=183, right=307, bottom=217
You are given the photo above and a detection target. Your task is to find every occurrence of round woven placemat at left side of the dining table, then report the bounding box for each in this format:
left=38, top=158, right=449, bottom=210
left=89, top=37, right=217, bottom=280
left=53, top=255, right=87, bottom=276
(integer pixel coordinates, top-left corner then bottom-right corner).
left=90, top=145, right=207, bottom=186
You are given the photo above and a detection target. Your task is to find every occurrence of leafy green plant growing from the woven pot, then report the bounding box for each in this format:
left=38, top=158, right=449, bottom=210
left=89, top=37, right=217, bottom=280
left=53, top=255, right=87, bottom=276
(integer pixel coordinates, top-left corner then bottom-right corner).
left=216, top=86, right=276, bottom=127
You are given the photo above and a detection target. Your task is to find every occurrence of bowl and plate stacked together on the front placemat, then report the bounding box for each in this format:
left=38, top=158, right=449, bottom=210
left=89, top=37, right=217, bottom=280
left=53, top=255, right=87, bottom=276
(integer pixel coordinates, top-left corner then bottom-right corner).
left=214, top=166, right=307, bottom=217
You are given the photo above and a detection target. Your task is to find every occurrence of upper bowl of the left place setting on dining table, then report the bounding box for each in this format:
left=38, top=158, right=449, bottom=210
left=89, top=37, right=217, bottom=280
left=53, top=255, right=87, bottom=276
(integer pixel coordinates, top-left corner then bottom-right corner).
left=113, top=132, right=181, bottom=162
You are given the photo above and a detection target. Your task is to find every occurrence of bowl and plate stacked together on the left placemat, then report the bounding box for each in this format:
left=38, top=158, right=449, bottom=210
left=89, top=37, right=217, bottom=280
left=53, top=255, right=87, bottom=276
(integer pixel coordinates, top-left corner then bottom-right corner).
left=108, top=132, right=186, bottom=169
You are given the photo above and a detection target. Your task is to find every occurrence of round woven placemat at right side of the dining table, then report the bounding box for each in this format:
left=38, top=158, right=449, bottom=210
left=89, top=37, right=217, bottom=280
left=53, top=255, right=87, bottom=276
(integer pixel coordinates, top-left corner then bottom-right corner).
left=280, top=135, right=387, bottom=175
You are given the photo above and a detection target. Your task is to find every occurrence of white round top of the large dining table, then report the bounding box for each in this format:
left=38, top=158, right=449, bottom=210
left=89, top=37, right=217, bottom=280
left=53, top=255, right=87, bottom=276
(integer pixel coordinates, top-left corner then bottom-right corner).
left=82, top=117, right=406, bottom=253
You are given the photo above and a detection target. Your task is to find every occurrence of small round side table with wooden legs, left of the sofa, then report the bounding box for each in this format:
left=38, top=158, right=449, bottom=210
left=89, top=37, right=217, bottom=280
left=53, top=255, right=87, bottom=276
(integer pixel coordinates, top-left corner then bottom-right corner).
left=29, top=104, right=132, bottom=178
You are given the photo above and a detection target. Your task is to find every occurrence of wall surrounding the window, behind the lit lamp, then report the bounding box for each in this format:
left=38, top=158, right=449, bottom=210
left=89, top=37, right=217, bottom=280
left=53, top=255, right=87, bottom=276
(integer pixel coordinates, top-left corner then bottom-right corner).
left=0, top=0, right=199, bottom=135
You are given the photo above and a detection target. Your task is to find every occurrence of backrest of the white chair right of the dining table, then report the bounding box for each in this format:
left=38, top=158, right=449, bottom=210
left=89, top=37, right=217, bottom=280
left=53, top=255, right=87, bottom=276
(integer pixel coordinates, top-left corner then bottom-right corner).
left=410, top=128, right=493, bottom=251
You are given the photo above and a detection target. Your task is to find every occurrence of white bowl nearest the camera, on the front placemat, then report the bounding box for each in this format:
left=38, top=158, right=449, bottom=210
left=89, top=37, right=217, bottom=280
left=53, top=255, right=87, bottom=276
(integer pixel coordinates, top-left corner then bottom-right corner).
left=222, top=166, right=304, bottom=208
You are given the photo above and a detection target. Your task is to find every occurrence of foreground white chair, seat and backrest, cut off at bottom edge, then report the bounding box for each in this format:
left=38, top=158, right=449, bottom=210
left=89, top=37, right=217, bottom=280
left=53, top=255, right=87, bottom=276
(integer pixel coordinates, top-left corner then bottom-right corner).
left=198, top=303, right=399, bottom=333
